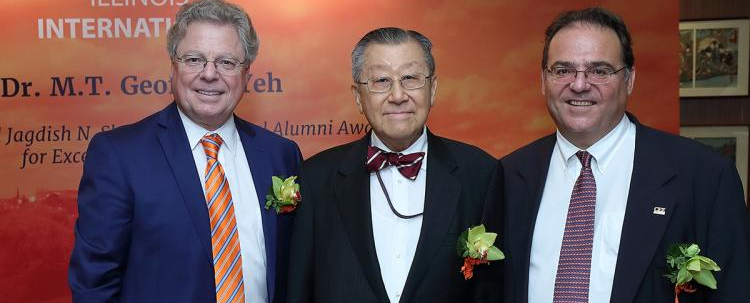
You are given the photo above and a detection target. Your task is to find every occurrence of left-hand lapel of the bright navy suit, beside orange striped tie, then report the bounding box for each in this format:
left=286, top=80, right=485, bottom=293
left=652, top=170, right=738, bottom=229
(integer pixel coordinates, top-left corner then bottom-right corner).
left=157, top=103, right=213, bottom=264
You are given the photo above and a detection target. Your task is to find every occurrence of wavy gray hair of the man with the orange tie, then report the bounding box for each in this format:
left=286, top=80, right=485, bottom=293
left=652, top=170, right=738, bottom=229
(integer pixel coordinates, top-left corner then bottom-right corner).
left=167, top=0, right=260, bottom=64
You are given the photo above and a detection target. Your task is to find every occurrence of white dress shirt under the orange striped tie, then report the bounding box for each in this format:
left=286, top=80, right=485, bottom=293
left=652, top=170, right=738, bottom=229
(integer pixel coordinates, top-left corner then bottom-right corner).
left=180, top=111, right=268, bottom=303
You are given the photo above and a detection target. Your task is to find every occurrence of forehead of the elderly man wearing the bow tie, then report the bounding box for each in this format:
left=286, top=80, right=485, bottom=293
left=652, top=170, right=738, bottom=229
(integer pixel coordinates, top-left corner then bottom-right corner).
left=363, top=41, right=427, bottom=72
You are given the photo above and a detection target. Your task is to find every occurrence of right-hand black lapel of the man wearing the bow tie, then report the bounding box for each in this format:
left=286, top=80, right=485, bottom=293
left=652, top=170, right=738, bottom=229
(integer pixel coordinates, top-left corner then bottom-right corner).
left=400, top=131, right=461, bottom=302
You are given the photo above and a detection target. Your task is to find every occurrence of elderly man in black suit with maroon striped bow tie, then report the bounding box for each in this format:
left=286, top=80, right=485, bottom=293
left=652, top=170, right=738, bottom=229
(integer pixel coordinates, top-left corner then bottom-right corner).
left=288, top=28, right=500, bottom=303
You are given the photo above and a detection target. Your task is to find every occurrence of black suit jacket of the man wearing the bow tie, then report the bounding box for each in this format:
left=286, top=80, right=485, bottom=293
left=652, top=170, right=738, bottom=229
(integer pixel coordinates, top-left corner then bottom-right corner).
left=288, top=132, right=501, bottom=303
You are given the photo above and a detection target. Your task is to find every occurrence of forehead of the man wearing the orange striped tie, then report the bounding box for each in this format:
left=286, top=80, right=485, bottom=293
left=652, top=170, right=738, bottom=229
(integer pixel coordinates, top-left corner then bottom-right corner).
left=177, top=21, right=242, bottom=55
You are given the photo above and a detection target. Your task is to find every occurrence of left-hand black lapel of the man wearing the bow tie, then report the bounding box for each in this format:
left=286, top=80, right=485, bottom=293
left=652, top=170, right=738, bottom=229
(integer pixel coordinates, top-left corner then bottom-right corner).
left=333, top=137, right=388, bottom=302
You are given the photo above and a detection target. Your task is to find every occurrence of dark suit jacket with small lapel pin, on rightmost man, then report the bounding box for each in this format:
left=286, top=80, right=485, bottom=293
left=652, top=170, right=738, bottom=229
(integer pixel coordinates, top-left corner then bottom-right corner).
left=488, top=116, right=750, bottom=303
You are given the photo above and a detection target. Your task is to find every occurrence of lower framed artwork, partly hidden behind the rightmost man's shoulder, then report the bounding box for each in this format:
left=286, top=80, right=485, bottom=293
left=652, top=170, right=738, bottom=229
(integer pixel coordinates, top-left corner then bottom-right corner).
left=680, top=126, right=750, bottom=203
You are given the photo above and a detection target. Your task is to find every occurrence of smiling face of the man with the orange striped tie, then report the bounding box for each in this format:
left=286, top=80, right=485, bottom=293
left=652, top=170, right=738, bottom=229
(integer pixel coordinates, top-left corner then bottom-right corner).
left=172, top=21, right=250, bottom=130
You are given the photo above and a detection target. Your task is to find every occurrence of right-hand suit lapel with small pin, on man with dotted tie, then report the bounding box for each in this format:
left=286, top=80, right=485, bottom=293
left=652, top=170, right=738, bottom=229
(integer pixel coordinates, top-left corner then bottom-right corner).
left=611, top=122, right=676, bottom=303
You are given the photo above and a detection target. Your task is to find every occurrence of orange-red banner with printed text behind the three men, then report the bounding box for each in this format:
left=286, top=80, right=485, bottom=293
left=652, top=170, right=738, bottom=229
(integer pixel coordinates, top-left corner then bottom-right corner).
left=0, top=0, right=679, bottom=302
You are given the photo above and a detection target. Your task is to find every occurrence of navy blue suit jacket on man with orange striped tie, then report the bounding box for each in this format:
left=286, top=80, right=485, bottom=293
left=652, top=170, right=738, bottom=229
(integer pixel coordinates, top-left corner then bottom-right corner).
left=69, top=103, right=301, bottom=303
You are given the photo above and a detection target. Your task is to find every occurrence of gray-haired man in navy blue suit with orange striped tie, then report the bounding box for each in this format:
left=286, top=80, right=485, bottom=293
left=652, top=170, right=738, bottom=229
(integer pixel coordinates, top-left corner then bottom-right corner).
left=69, top=0, right=301, bottom=303
